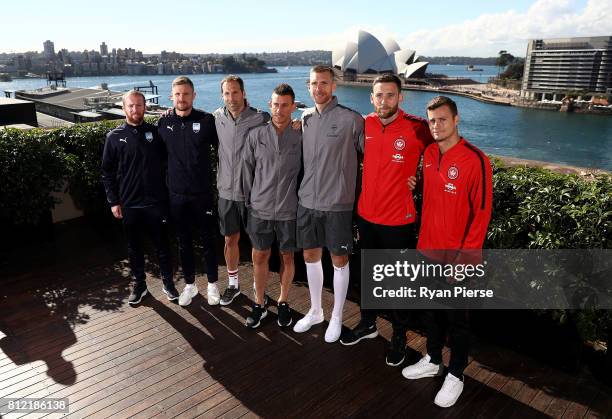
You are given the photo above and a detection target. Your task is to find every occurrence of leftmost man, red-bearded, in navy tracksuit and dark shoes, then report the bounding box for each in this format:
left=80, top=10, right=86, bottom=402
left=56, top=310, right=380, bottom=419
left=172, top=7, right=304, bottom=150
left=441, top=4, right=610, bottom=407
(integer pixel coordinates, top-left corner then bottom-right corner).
left=102, top=91, right=172, bottom=304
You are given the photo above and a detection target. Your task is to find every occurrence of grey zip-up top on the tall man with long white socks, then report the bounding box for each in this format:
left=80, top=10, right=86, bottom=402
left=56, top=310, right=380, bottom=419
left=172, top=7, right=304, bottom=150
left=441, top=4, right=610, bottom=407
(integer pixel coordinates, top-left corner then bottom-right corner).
left=298, top=96, right=364, bottom=211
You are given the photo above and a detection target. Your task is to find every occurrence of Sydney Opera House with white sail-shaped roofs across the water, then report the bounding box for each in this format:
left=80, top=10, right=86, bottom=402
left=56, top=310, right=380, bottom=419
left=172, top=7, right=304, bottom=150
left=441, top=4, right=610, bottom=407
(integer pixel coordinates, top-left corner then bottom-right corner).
left=332, top=30, right=429, bottom=81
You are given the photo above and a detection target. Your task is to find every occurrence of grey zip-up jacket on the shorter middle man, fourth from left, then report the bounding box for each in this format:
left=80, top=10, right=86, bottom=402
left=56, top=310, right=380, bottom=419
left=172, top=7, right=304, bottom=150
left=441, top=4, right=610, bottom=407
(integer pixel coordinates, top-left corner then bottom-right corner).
left=242, top=122, right=302, bottom=221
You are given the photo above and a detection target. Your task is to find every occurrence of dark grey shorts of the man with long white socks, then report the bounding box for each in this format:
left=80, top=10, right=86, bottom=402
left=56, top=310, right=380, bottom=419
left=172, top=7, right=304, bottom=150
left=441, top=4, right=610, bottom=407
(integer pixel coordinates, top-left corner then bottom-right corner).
left=297, top=205, right=353, bottom=256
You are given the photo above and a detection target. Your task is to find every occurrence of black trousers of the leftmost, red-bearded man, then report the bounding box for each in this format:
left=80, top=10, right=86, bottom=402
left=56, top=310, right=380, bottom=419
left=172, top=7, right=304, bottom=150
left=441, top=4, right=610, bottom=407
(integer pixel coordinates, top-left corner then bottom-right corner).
left=121, top=203, right=172, bottom=282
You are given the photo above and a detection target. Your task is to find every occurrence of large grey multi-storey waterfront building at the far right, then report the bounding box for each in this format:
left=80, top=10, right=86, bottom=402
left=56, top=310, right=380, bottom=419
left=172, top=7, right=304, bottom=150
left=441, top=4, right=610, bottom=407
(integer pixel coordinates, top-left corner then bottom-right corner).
left=521, top=36, right=612, bottom=100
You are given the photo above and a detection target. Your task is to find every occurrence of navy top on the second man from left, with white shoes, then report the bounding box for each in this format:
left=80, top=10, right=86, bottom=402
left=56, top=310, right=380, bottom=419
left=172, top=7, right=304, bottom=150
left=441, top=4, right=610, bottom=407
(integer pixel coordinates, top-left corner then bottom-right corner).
left=157, top=109, right=219, bottom=198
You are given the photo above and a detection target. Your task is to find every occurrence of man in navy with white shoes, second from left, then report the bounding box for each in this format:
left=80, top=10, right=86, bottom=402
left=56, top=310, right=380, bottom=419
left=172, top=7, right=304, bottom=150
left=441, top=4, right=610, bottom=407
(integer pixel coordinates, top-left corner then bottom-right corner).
left=157, top=76, right=220, bottom=306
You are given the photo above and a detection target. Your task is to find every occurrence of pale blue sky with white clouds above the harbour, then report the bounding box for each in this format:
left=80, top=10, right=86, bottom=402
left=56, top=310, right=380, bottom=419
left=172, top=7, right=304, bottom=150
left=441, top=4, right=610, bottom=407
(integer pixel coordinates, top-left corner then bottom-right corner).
left=0, top=0, right=612, bottom=56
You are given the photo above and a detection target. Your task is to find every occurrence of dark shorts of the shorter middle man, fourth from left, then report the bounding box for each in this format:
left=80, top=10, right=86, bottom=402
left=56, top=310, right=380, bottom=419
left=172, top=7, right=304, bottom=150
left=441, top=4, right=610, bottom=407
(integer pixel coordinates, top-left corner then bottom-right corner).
left=246, top=214, right=297, bottom=252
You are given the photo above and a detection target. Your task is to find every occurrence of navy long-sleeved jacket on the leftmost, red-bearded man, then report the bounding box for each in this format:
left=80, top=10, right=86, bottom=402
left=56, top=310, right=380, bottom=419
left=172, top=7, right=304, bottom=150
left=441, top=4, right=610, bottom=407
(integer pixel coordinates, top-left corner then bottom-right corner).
left=102, top=122, right=168, bottom=208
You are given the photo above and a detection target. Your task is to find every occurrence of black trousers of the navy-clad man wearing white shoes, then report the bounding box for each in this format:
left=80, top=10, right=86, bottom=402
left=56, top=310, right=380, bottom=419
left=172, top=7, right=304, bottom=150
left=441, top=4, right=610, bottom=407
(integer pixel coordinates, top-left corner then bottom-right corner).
left=170, top=193, right=219, bottom=284
